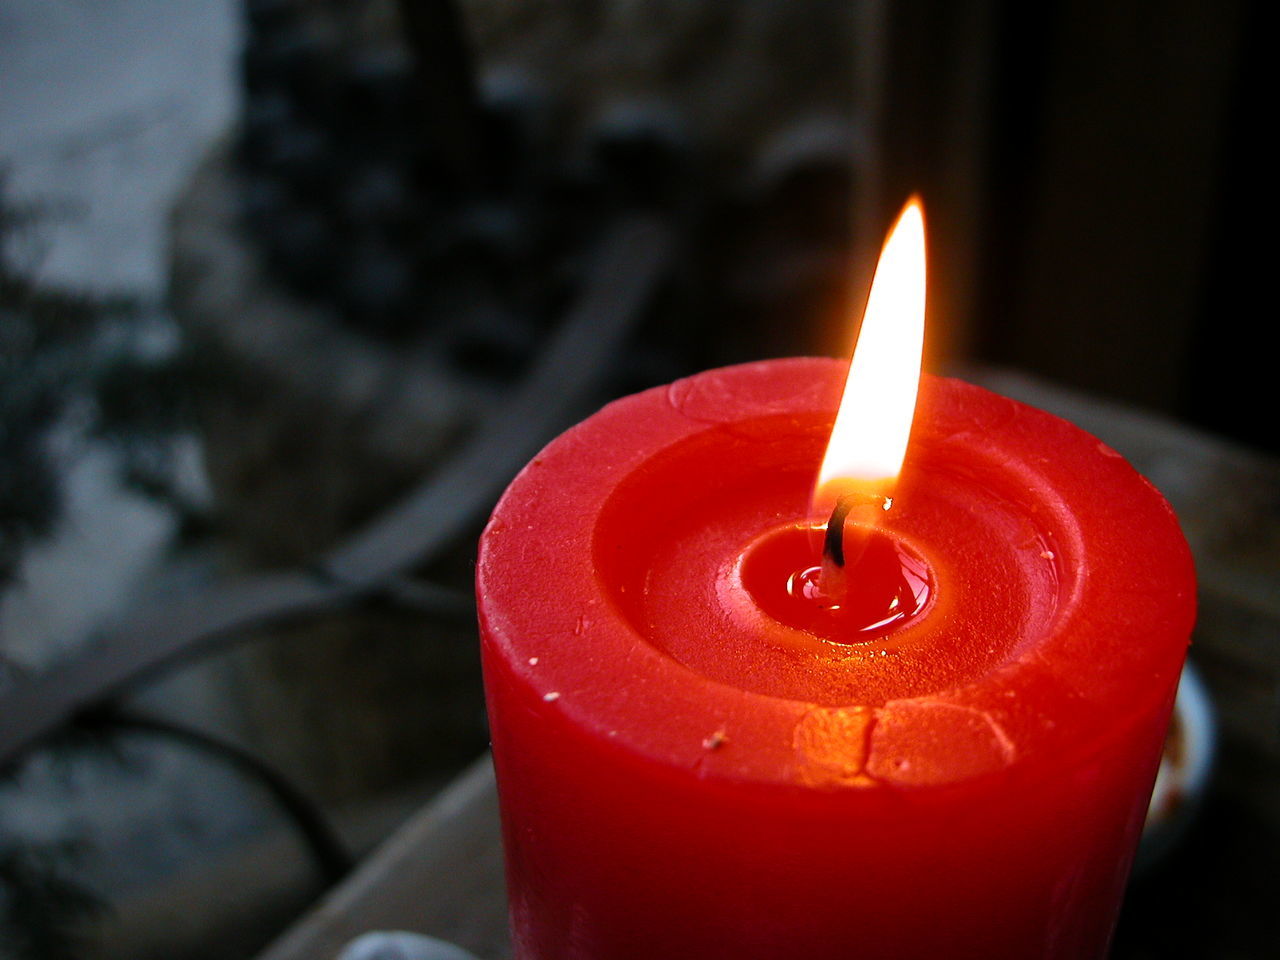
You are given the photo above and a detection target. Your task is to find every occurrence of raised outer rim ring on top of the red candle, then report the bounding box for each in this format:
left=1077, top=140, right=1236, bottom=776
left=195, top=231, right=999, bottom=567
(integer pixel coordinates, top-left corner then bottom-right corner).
left=476, top=358, right=1194, bottom=787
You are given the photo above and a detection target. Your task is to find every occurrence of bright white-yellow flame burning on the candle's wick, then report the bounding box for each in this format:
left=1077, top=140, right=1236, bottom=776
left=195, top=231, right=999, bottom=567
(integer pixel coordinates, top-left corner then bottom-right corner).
left=813, top=197, right=924, bottom=517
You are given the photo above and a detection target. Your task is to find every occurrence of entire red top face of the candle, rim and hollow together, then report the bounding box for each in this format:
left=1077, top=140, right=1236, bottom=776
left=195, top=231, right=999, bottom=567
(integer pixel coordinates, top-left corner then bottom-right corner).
left=477, top=358, right=1194, bottom=788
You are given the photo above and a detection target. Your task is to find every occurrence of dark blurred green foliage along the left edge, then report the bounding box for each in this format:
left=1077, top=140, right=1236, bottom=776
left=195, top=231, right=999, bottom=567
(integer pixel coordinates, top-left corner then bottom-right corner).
left=0, top=170, right=200, bottom=960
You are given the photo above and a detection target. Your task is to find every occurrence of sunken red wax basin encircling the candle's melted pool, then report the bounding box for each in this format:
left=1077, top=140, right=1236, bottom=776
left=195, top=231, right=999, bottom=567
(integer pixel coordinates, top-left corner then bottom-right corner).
left=593, top=424, right=1079, bottom=707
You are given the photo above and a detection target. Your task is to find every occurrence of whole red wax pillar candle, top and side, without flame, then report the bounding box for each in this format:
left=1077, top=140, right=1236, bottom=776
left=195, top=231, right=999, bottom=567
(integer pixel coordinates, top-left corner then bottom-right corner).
left=477, top=360, right=1194, bottom=960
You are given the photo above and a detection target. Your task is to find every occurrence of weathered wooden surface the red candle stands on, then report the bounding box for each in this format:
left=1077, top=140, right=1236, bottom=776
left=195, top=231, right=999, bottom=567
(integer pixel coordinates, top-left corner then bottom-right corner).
left=260, top=371, right=1280, bottom=960
